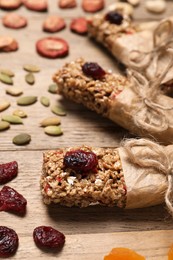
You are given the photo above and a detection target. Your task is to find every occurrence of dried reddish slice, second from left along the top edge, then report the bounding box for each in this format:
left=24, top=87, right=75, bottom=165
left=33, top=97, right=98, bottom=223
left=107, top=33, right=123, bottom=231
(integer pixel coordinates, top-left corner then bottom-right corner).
left=23, top=0, right=48, bottom=12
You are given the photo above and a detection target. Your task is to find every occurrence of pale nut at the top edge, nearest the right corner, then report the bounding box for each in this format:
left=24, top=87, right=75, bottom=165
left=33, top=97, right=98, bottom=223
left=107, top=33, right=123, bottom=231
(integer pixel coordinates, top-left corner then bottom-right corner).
left=145, top=0, right=166, bottom=14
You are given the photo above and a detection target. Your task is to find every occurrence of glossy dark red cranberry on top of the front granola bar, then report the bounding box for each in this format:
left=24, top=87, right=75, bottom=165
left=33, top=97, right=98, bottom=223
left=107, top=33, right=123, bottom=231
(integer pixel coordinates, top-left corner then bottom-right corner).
left=64, top=150, right=98, bottom=173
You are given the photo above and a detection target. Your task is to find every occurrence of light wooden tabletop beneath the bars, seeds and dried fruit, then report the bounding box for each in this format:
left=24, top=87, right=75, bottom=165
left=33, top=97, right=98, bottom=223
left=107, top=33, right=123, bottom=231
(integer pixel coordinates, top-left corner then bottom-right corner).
left=0, top=0, right=173, bottom=260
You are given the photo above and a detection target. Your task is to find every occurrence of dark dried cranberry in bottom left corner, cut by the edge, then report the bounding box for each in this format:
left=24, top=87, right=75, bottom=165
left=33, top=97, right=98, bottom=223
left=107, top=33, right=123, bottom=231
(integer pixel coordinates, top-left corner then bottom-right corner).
left=0, top=226, right=19, bottom=257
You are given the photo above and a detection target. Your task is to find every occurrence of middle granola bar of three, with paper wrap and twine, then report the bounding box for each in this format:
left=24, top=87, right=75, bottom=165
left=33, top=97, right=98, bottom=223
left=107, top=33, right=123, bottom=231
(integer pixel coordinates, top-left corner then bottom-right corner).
left=53, top=56, right=173, bottom=144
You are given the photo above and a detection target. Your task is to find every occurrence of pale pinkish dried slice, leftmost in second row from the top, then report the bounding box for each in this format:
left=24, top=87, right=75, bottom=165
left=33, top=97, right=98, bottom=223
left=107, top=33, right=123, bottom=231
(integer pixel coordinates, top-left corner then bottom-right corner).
left=2, top=13, right=27, bottom=29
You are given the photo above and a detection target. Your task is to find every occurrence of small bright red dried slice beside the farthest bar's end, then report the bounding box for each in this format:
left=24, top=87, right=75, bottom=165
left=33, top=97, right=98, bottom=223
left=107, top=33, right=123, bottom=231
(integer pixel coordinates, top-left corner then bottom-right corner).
left=70, top=17, right=88, bottom=34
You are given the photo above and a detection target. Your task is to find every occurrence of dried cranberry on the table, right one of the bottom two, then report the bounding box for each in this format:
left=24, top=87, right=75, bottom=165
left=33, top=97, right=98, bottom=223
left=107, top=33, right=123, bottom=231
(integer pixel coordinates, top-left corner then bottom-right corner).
left=33, top=226, right=65, bottom=249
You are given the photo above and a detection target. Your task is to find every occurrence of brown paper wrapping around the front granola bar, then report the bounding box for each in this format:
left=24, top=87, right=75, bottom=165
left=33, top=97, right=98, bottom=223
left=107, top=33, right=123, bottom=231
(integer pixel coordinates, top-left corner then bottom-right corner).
left=118, top=147, right=168, bottom=209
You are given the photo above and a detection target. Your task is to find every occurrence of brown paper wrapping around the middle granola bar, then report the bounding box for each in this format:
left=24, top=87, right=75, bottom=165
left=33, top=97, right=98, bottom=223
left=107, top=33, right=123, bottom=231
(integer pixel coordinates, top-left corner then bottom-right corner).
left=107, top=88, right=173, bottom=144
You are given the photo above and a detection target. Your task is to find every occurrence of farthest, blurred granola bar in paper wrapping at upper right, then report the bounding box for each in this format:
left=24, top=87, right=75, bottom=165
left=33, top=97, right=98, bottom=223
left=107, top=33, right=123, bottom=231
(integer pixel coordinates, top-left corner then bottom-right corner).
left=88, top=12, right=173, bottom=86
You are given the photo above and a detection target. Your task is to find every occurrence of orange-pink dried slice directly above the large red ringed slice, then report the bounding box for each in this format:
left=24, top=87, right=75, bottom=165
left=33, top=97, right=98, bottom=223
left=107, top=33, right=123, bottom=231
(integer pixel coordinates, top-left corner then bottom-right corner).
left=43, top=15, right=66, bottom=33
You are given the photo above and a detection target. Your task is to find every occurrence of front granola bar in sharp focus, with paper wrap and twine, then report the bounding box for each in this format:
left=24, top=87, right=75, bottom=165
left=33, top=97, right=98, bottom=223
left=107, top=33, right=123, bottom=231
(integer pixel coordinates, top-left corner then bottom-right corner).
left=41, top=139, right=173, bottom=212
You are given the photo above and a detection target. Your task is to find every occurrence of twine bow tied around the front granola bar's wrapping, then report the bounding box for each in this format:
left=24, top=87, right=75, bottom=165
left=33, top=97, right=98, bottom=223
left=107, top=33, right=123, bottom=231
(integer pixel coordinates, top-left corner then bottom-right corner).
left=123, top=139, right=173, bottom=216
